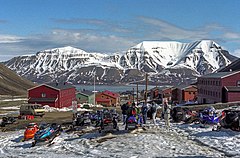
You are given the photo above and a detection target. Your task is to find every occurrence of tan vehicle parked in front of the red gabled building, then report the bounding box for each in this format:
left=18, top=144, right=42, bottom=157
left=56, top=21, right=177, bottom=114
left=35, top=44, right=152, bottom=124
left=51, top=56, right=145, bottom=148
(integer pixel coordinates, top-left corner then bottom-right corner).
left=20, top=104, right=45, bottom=117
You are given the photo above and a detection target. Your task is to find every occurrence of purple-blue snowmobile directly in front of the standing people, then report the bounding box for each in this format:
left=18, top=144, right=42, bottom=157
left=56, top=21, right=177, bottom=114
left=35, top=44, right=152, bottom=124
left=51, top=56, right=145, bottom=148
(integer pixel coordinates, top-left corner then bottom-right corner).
left=125, top=114, right=143, bottom=130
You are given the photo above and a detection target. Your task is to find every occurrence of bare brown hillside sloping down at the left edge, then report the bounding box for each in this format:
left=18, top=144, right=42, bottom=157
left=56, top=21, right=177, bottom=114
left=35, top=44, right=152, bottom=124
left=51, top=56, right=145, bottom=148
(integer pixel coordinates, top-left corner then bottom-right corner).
left=0, top=63, right=34, bottom=95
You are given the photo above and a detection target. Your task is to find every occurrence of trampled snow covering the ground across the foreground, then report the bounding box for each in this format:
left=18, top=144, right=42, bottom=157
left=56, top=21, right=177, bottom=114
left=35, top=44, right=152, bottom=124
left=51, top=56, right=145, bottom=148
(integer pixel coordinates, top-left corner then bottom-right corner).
left=0, top=121, right=240, bottom=158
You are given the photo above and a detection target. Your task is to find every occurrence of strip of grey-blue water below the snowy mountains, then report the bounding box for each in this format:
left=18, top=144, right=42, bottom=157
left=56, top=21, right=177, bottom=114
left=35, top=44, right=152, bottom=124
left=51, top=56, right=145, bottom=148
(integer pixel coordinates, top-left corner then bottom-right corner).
left=74, top=85, right=156, bottom=92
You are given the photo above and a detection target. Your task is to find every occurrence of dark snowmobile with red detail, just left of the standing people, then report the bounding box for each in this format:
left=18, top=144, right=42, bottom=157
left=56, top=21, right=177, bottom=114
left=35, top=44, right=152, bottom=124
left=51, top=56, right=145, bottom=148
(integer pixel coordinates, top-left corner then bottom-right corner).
left=97, top=110, right=119, bottom=133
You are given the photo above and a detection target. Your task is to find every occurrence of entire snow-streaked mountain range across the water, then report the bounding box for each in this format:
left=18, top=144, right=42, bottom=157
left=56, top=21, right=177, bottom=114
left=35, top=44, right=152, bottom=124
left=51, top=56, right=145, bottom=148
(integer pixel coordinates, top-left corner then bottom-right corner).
left=4, top=40, right=234, bottom=84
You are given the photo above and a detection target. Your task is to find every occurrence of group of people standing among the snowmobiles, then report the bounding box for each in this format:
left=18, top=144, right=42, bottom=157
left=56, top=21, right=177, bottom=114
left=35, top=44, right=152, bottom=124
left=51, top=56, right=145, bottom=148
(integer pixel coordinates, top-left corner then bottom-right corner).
left=121, top=101, right=171, bottom=128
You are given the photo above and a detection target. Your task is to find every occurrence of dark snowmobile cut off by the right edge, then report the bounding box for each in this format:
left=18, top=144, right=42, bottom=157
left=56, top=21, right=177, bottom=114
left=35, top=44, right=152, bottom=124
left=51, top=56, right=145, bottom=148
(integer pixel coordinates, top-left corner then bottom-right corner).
left=220, top=109, right=240, bottom=131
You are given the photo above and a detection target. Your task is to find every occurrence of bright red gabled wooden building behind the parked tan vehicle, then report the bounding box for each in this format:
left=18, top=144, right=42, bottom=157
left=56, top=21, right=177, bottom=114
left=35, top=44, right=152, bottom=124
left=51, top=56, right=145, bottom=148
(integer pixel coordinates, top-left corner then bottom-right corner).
left=28, top=83, right=76, bottom=108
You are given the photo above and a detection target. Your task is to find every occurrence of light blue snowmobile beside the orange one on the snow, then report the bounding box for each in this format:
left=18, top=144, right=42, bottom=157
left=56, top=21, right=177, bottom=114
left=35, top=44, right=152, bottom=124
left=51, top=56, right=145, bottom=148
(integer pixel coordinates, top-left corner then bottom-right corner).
left=32, top=123, right=62, bottom=147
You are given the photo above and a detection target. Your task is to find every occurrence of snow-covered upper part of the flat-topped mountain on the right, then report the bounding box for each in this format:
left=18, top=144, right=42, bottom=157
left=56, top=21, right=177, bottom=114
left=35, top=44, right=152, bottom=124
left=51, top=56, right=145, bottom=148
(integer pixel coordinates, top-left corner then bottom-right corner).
left=120, top=40, right=232, bottom=74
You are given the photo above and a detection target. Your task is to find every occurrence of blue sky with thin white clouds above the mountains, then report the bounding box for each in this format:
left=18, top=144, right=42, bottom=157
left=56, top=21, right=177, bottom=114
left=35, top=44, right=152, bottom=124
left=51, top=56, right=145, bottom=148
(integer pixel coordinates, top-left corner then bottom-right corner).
left=0, top=0, right=240, bottom=61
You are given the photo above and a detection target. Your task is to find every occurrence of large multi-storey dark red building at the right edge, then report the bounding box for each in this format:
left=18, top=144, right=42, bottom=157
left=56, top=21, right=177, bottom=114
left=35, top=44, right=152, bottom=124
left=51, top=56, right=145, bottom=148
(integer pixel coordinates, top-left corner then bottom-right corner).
left=197, top=71, right=240, bottom=104
